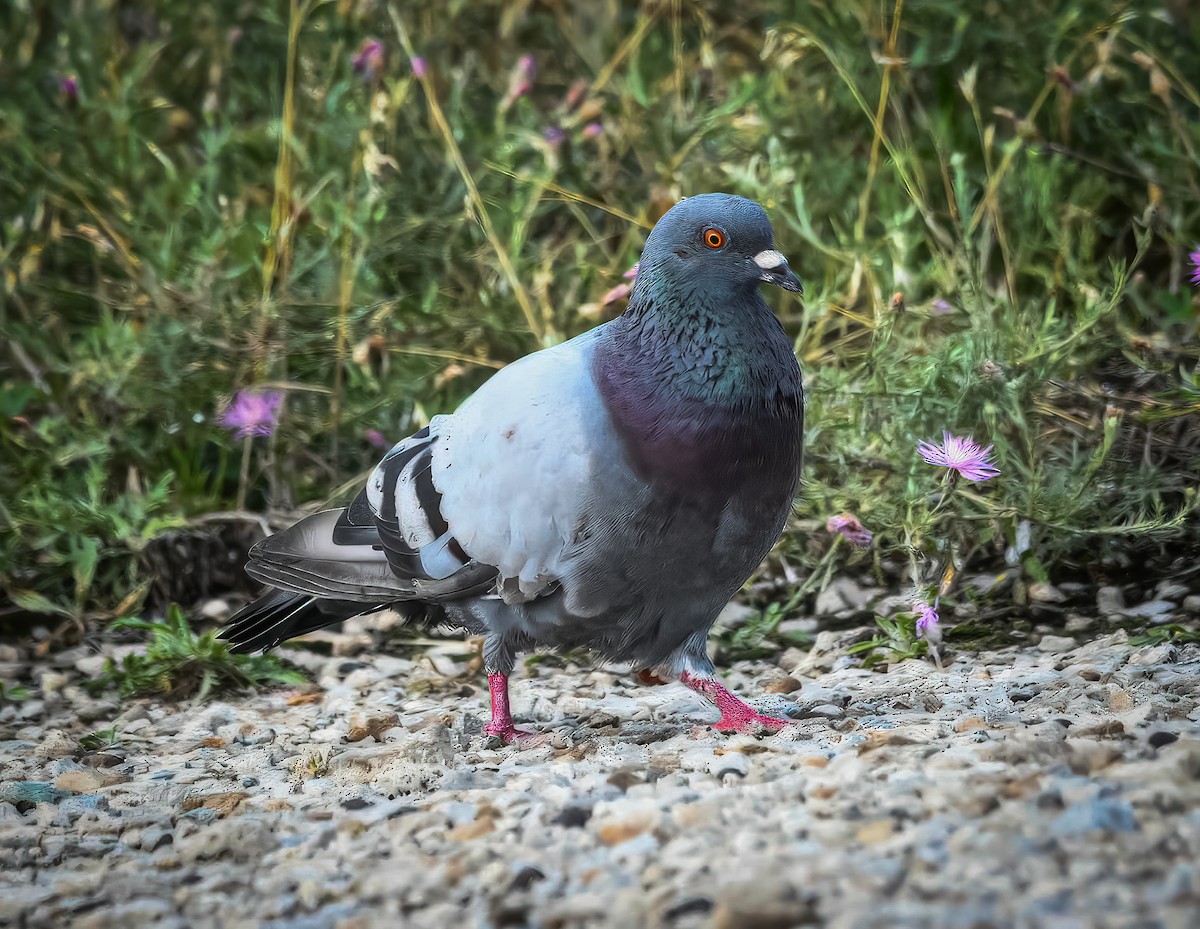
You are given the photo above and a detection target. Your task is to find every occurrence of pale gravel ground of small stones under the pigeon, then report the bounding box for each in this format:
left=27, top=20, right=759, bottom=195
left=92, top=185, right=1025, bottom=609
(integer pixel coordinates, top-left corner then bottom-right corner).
left=0, top=633, right=1200, bottom=929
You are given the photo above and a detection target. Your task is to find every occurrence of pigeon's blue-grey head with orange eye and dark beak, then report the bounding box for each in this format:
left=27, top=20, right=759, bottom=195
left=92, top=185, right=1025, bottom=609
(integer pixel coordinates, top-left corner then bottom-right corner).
left=637, top=193, right=804, bottom=296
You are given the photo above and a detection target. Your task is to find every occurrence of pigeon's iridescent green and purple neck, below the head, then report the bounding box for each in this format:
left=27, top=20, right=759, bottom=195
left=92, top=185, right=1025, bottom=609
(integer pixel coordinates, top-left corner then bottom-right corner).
left=592, top=283, right=804, bottom=496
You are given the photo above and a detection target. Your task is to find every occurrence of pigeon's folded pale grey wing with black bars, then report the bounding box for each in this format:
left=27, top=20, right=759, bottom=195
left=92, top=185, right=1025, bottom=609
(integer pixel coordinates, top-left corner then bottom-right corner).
left=246, top=334, right=616, bottom=612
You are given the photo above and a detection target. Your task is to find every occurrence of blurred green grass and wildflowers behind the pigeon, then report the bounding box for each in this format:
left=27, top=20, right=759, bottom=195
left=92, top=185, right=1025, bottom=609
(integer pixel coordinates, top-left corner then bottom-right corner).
left=0, top=0, right=1200, bottom=621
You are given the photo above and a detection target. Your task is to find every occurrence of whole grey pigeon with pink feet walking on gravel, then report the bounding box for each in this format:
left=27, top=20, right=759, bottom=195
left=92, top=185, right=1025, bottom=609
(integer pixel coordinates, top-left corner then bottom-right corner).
left=221, top=193, right=804, bottom=745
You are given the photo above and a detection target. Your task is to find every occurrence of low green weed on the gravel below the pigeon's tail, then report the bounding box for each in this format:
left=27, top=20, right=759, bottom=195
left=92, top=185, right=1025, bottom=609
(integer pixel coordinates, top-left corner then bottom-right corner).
left=95, top=605, right=306, bottom=700
